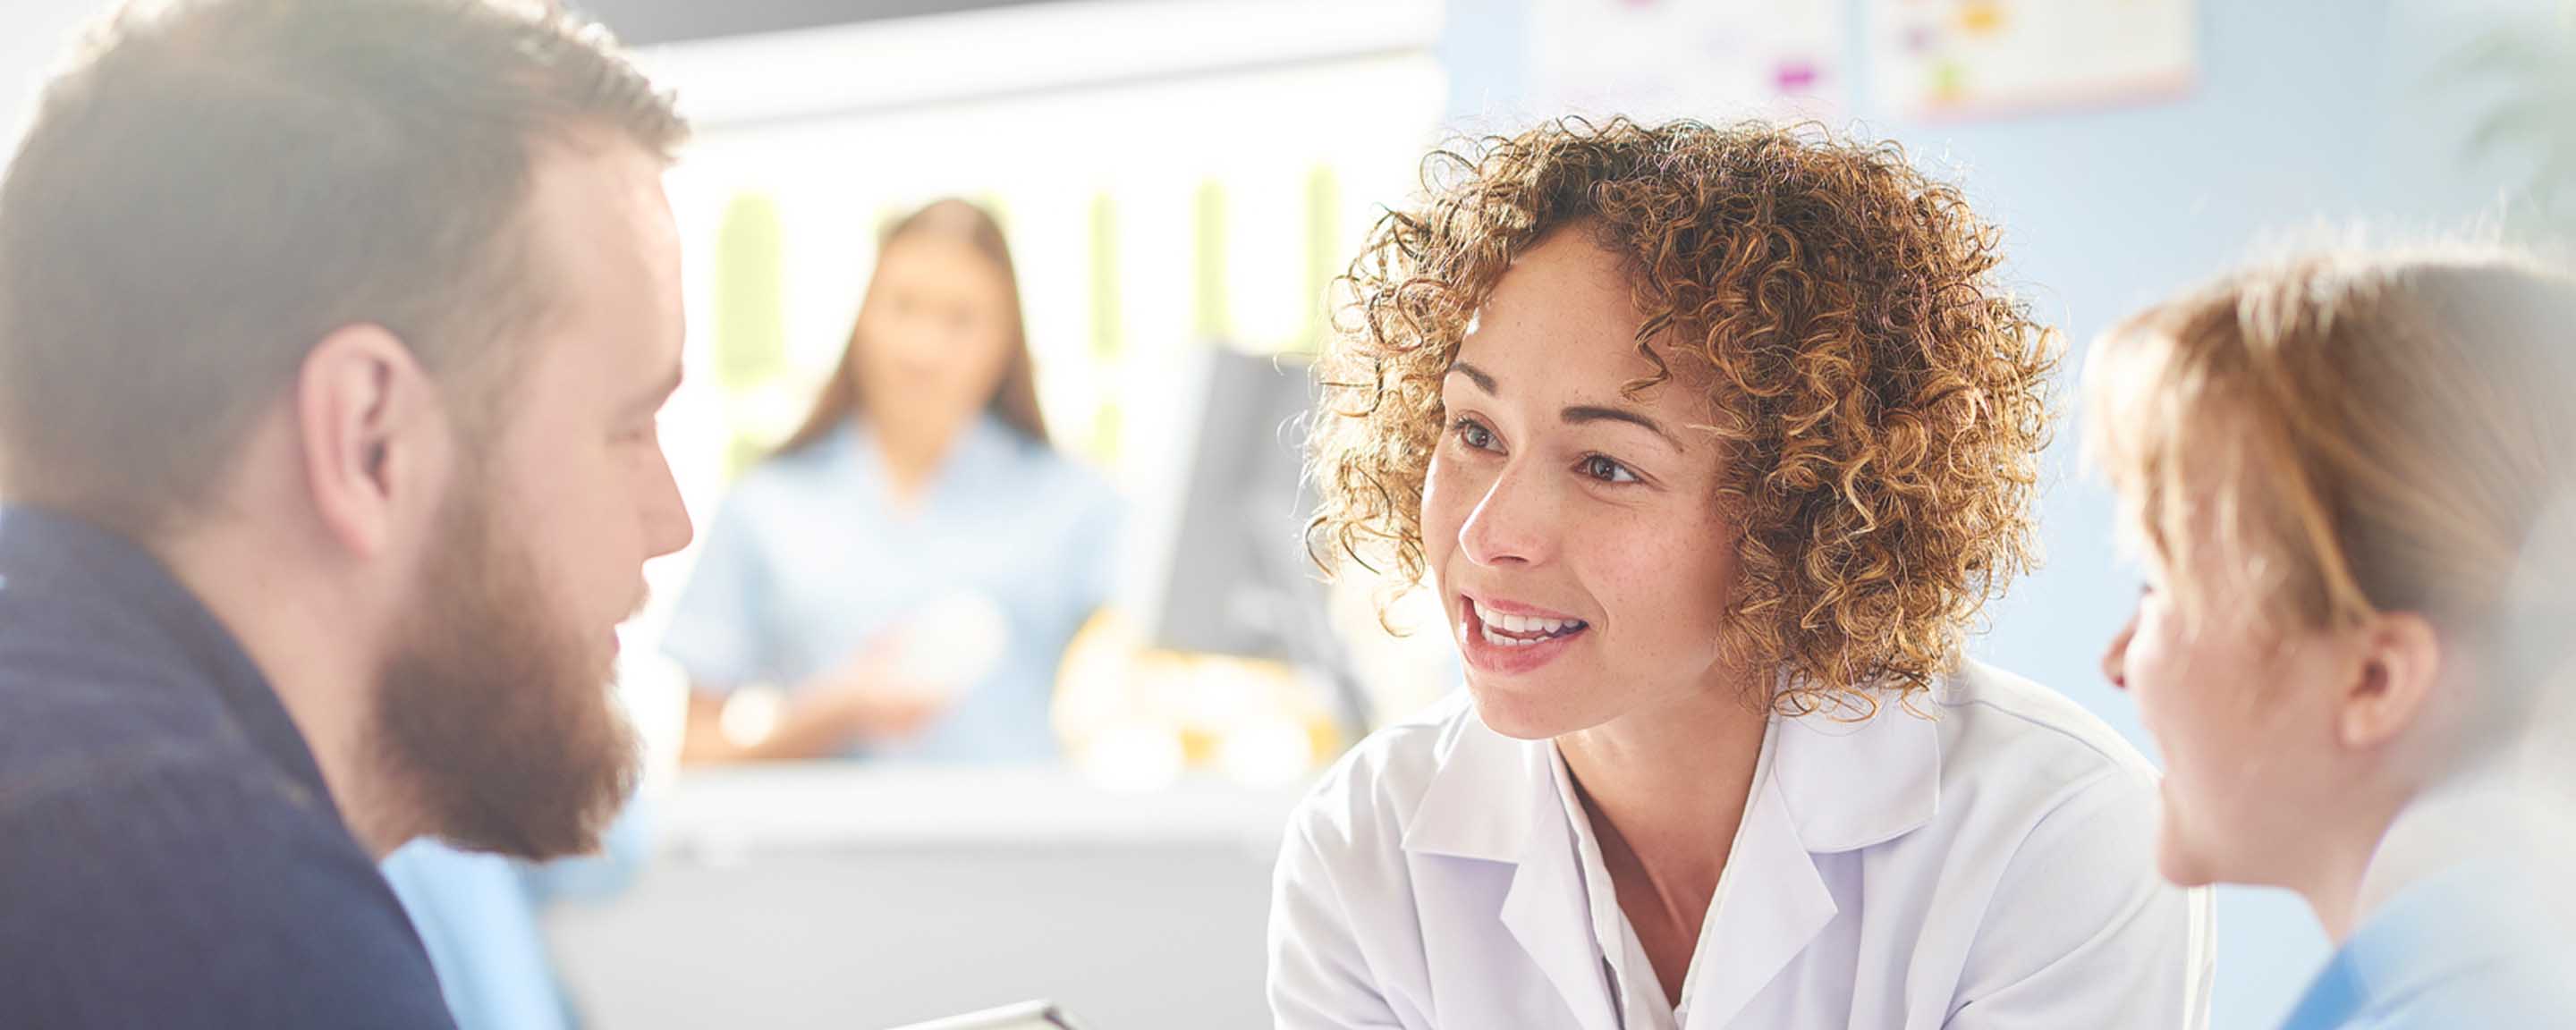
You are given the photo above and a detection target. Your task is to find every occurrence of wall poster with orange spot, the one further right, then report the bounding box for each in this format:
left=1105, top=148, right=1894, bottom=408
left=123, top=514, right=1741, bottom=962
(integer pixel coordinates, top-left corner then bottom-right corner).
left=1868, top=0, right=2195, bottom=118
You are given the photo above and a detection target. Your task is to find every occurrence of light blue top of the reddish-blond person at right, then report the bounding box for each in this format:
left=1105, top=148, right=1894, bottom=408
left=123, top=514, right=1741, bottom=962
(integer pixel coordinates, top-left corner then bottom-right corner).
left=2283, top=860, right=2576, bottom=1030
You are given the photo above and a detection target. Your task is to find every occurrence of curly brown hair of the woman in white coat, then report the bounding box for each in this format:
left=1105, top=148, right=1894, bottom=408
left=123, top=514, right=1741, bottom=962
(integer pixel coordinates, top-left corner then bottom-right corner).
left=1309, top=118, right=2058, bottom=713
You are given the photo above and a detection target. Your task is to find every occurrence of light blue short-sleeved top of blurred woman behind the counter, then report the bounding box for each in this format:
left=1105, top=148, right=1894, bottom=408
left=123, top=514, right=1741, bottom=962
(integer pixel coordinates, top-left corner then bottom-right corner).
left=662, top=415, right=1118, bottom=762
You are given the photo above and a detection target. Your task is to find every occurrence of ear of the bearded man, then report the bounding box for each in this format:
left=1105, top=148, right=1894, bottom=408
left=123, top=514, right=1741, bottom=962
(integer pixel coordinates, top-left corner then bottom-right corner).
left=293, top=325, right=451, bottom=556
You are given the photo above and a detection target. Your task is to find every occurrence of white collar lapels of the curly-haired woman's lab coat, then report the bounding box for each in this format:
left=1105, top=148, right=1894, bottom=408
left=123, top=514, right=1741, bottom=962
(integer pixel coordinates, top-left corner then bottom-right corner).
left=1404, top=685, right=1940, bottom=1030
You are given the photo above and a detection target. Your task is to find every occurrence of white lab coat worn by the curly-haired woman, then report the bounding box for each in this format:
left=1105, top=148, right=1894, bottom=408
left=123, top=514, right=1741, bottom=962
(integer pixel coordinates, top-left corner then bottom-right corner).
left=1270, top=667, right=2210, bottom=1030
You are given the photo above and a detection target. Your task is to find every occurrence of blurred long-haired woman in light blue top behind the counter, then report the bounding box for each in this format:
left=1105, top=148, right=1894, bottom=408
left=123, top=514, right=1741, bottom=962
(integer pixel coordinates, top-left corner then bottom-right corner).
left=662, top=201, right=1118, bottom=762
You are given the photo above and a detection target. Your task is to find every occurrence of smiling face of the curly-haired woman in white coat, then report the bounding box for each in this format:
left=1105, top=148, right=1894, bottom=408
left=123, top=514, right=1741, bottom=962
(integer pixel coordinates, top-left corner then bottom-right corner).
left=1422, top=232, right=1736, bottom=739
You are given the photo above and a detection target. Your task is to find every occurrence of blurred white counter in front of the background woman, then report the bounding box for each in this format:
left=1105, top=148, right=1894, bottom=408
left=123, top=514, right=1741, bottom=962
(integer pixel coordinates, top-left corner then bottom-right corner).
left=547, top=764, right=1303, bottom=1030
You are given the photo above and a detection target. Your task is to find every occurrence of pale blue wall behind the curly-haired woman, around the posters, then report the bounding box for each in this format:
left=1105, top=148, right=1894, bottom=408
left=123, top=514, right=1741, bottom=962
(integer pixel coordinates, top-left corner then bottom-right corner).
left=1443, top=0, right=2532, bottom=1030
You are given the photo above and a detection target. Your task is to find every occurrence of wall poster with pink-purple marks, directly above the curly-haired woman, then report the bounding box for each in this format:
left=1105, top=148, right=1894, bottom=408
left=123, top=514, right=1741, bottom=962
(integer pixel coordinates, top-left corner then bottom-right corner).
left=1530, top=0, right=1847, bottom=121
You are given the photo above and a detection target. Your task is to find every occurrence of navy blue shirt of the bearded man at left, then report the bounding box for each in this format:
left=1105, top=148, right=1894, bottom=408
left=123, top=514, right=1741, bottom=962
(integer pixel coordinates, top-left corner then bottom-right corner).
left=0, top=507, right=453, bottom=1027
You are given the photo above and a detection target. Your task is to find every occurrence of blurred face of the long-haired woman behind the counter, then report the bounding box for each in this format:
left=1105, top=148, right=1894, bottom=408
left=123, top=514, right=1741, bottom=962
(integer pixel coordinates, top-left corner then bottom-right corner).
left=852, top=232, right=1015, bottom=437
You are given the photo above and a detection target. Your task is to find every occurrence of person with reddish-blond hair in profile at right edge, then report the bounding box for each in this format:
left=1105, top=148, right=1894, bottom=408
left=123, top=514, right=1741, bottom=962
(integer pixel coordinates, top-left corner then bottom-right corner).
left=2087, top=252, right=2576, bottom=1030
